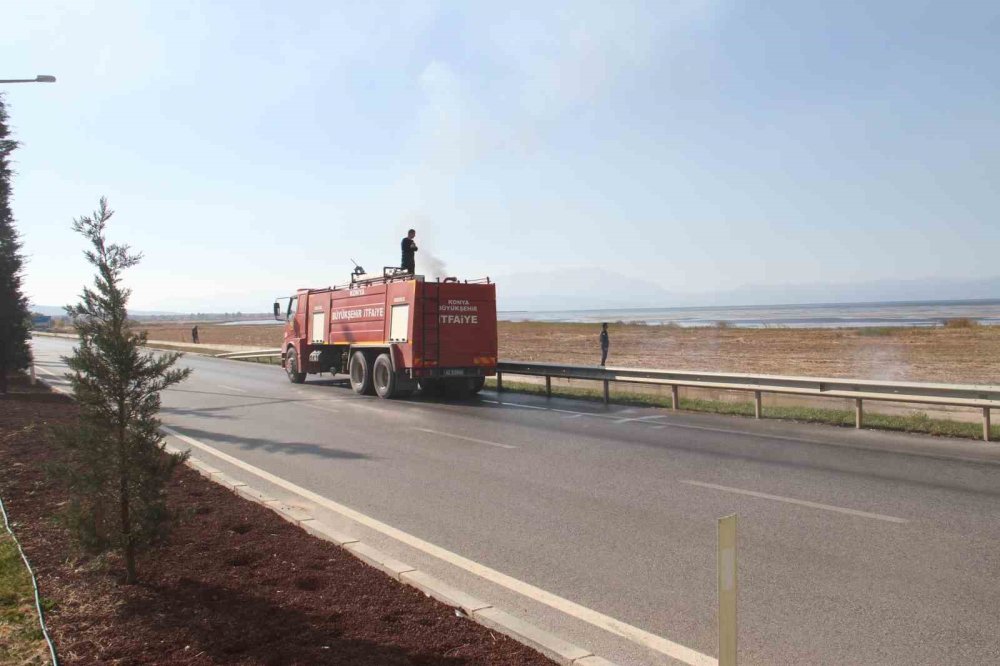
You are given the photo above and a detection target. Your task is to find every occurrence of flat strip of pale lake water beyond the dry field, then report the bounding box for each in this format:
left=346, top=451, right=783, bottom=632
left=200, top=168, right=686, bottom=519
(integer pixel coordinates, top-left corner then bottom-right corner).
left=498, top=299, right=1000, bottom=328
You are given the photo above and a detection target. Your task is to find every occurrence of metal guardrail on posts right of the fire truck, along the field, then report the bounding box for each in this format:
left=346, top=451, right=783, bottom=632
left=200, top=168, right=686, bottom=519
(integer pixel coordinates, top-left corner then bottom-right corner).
left=497, top=361, right=1000, bottom=441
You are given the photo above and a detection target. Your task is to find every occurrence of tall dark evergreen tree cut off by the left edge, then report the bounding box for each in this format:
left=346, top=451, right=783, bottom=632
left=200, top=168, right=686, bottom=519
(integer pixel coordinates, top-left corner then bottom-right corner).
left=0, top=95, right=31, bottom=393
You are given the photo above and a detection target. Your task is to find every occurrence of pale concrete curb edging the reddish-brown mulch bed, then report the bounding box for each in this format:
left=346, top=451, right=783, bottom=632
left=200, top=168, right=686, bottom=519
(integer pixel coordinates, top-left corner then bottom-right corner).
left=166, top=444, right=615, bottom=666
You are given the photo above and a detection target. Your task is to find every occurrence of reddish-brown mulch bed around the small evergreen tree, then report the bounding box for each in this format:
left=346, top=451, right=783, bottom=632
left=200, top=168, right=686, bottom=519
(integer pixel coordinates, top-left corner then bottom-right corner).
left=0, top=382, right=552, bottom=666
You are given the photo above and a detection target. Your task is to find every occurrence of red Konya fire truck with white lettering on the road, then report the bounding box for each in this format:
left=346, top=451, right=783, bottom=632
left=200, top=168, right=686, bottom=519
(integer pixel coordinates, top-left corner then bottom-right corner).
left=274, top=267, right=497, bottom=398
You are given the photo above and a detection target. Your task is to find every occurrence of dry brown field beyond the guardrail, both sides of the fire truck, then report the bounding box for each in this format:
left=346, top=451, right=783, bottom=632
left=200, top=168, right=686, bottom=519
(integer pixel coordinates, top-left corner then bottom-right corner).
left=129, top=322, right=1000, bottom=384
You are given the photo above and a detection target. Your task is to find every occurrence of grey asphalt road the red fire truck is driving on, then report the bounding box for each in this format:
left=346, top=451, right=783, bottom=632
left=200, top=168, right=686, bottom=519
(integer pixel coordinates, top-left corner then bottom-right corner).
left=35, top=338, right=1000, bottom=665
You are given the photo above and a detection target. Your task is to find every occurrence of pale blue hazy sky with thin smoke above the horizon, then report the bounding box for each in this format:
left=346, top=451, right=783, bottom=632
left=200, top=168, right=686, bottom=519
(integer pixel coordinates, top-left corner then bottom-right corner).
left=0, top=0, right=1000, bottom=311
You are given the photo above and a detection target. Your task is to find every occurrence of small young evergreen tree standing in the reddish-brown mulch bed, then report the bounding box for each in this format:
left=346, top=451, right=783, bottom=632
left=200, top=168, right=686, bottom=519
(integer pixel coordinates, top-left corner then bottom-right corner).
left=63, top=198, right=191, bottom=583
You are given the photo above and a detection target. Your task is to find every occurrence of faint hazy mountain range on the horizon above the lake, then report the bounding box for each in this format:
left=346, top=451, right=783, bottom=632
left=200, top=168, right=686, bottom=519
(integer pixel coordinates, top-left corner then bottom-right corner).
left=497, top=268, right=1000, bottom=312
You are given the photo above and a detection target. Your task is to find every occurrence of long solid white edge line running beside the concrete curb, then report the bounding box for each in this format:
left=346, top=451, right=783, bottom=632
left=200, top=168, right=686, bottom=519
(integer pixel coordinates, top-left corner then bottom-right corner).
left=160, top=426, right=718, bottom=666
